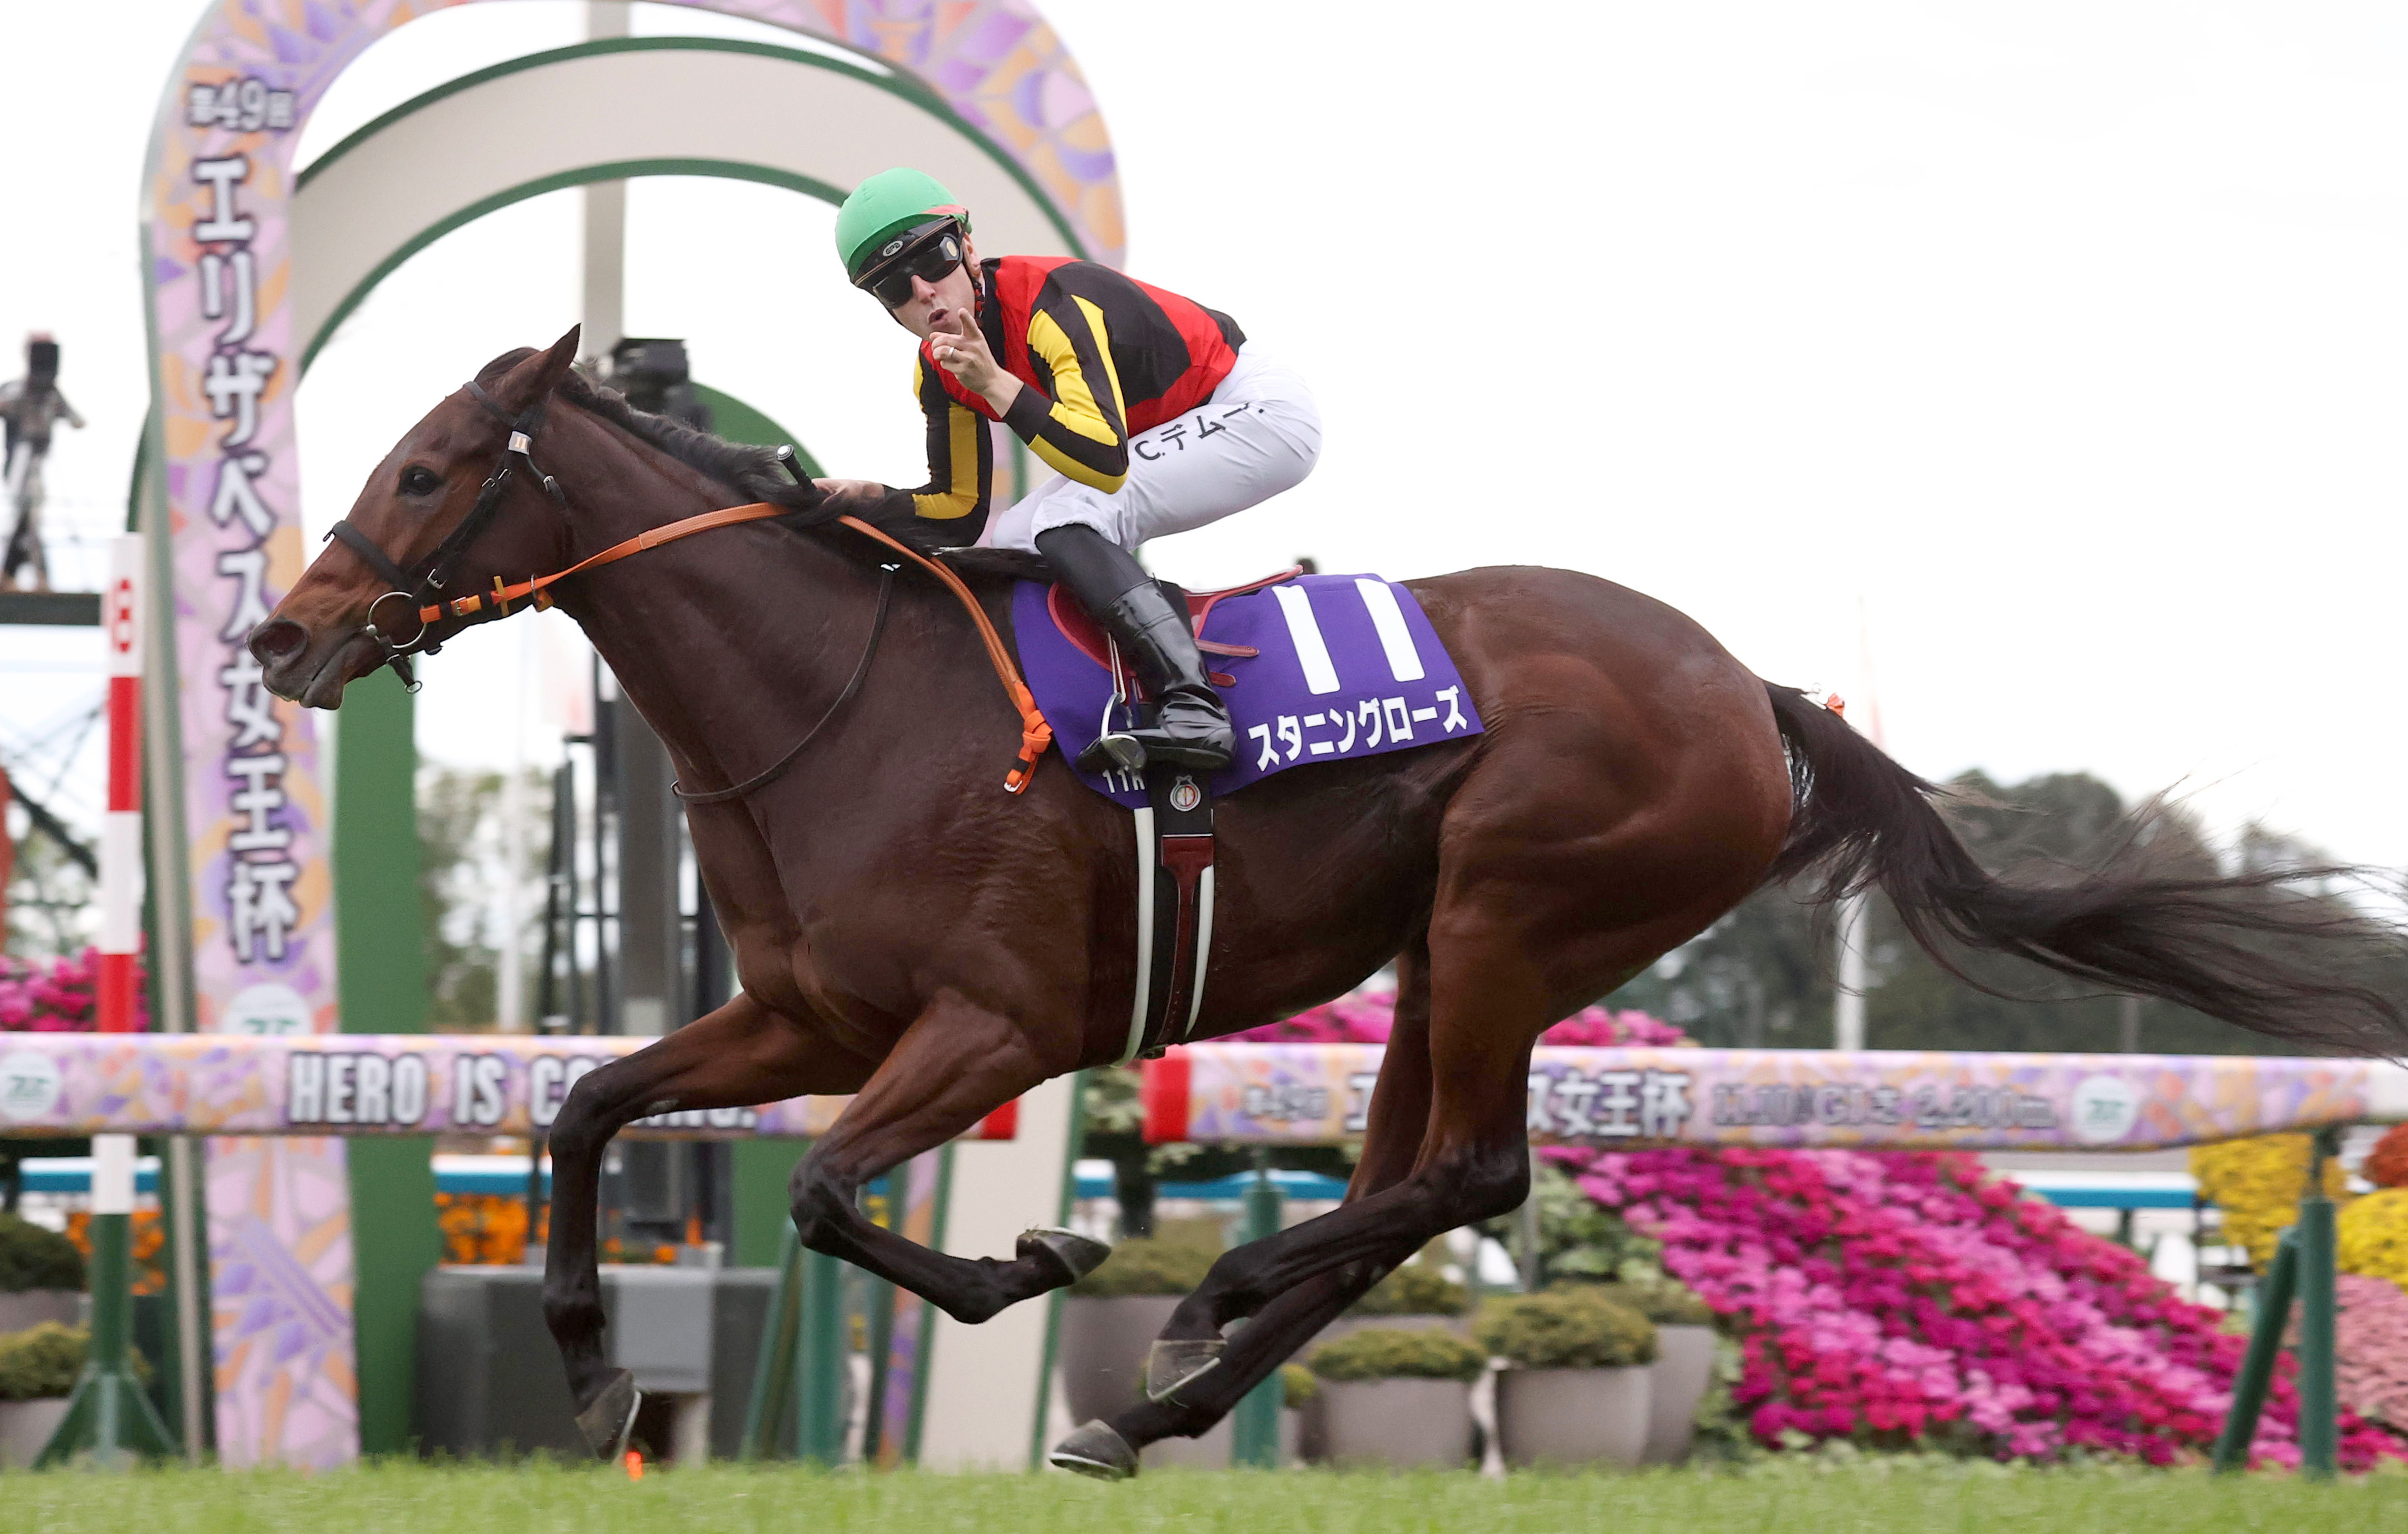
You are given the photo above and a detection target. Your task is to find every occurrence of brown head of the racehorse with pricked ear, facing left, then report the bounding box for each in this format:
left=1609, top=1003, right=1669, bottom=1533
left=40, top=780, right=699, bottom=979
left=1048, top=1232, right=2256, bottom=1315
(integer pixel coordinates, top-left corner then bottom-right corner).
left=251, top=328, right=578, bottom=708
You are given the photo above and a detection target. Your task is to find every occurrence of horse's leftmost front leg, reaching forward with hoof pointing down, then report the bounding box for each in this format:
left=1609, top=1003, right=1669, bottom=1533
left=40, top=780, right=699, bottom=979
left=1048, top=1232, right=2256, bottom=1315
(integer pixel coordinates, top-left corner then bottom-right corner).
left=544, top=995, right=869, bottom=1459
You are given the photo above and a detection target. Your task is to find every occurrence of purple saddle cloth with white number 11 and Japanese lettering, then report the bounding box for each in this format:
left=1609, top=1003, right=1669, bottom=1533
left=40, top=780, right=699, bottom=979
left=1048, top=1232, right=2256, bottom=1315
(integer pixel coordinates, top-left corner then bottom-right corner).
left=1012, top=576, right=1481, bottom=809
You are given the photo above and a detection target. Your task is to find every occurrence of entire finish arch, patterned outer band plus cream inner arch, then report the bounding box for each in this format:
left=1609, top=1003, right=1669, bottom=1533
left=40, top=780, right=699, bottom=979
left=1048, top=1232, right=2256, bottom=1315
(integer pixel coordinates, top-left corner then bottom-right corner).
left=140, top=0, right=1122, bottom=1467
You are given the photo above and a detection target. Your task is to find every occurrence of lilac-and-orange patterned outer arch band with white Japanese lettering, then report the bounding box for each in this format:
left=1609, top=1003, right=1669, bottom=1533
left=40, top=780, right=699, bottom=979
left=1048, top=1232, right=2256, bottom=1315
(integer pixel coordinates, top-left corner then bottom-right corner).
left=144, top=0, right=1122, bottom=1464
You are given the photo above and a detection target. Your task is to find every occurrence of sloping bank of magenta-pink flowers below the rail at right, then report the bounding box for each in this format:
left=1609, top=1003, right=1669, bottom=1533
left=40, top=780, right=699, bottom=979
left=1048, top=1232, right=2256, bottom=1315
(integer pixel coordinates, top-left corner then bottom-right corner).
left=1546, top=1149, right=2408, bottom=1469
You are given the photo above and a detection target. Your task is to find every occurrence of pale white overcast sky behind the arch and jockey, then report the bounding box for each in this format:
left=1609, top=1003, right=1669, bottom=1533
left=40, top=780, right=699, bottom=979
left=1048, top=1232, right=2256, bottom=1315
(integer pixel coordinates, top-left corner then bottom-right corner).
left=0, top=0, right=2408, bottom=865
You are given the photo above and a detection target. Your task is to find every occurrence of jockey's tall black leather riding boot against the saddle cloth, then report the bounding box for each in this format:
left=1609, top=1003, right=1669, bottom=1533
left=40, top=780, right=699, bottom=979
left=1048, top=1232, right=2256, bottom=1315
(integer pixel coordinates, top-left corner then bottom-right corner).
left=1038, top=522, right=1238, bottom=773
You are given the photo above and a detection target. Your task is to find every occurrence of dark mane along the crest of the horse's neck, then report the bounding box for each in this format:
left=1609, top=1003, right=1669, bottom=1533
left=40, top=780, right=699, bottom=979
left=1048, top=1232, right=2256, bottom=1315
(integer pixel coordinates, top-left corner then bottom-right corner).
left=477, top=347, right=1052, bottom=580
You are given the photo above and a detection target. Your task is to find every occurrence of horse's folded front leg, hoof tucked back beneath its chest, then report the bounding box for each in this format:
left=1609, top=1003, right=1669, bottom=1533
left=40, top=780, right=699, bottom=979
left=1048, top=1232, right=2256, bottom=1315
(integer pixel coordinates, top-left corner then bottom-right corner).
left=792, top=992, right=1110, bottom=1322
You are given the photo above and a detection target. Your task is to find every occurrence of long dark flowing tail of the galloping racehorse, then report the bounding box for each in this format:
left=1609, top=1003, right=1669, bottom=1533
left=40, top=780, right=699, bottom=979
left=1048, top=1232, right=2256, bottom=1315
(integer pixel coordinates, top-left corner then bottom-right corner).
left=1768, top=684, right=2408, bottom=1055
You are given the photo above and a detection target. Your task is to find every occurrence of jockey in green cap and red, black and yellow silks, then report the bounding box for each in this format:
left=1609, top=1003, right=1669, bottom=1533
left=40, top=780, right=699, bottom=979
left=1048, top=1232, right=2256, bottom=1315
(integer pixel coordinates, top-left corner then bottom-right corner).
left=819, top=169, right=1322, bottom=773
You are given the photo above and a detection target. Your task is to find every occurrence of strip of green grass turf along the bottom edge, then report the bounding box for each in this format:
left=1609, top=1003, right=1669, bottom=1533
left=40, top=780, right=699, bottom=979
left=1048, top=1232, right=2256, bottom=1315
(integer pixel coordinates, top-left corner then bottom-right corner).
left=0, top=1462, right=2408, bottom=1534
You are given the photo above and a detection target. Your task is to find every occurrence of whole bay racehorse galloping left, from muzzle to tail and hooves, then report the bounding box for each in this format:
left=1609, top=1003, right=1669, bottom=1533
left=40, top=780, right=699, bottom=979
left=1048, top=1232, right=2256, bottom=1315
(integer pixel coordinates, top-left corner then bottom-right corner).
left=251, top=330, right=2408, bottom=1474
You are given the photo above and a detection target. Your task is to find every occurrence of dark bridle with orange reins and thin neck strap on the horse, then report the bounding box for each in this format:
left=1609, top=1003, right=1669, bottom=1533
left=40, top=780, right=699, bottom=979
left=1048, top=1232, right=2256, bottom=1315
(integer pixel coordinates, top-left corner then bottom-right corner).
left=328, top=378, right=1052, bottom=804
